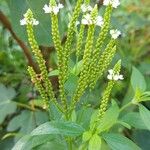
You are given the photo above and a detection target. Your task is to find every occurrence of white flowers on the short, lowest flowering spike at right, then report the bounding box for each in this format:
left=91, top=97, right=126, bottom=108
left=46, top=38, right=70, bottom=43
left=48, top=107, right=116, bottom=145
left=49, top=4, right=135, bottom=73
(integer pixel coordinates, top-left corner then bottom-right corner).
left=107, top=69, right=124, bottom=81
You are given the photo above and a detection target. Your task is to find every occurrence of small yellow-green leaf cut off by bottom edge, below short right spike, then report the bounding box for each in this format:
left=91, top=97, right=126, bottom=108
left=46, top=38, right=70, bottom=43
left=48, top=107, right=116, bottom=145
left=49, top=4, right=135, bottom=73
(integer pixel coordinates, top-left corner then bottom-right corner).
left=88, top=134, right=101, bottom=150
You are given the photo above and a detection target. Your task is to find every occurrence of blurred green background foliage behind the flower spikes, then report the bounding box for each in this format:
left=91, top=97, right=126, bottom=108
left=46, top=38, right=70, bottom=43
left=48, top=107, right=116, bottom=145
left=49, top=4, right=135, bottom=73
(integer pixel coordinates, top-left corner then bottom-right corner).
left=0, top=0, right=150, bottom=150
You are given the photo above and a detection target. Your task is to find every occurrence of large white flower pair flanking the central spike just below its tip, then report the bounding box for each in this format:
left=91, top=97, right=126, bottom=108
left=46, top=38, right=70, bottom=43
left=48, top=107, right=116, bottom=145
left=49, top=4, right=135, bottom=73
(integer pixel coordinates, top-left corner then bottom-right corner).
left=81, top=14, right=104, bottom=27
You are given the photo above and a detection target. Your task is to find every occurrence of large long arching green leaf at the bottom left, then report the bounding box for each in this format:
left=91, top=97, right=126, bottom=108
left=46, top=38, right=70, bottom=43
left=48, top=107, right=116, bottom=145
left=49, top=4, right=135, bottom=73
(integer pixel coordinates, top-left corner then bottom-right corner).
left=12, top=121, right=84, bottom=150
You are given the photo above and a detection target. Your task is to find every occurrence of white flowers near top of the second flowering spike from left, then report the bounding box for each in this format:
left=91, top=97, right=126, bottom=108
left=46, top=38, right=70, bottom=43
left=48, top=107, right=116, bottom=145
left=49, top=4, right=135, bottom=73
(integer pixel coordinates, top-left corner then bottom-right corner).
left=43, top=3, right=64, bottom=15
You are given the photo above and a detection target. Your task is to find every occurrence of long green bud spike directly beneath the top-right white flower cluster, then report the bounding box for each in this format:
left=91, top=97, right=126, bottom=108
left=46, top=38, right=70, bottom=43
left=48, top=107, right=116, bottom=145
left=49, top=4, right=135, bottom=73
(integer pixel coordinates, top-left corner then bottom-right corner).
left=90, top=5, right=112, bottom=88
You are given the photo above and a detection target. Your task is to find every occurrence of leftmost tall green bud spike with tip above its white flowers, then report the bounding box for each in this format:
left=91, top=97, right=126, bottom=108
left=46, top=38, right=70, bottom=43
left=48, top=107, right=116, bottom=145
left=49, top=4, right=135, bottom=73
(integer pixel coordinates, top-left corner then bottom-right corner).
left=25, top=9, right=62, bottom=112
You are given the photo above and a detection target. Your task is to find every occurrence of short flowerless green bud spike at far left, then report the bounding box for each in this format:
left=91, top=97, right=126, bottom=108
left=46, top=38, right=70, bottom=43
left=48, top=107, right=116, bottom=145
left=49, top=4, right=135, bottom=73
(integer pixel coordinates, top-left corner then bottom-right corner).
left=28, top=66, right=49, bottom=109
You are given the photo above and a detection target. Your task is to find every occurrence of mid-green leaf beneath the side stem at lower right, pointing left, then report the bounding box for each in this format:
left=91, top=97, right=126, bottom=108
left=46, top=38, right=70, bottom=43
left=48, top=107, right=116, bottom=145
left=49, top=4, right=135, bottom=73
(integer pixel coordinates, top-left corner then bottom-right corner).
left=121, top=112, right=147, bottom=129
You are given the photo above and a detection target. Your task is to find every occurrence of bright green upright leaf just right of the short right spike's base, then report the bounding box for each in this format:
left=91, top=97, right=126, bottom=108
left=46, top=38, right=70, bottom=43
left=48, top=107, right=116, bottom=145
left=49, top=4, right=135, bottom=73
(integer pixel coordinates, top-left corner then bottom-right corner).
left=97, top=104, right=119, bottom=133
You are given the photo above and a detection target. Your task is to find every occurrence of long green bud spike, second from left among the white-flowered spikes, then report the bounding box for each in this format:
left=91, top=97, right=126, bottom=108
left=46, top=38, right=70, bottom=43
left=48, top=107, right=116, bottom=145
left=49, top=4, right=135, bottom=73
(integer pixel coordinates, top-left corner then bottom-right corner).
left=50, top=0, right=67, bottom=111
